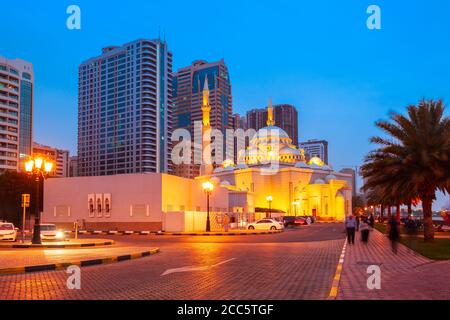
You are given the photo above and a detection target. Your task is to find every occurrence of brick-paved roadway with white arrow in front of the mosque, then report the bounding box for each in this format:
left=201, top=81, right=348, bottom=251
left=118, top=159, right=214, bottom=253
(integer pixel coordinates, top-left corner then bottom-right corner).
left=0, top=225, right=344, bottom=300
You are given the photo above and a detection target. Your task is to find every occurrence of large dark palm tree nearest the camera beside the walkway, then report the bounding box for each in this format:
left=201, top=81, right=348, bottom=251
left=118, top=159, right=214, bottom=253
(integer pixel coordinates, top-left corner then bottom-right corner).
left=362, top=100, right=450, bottom=240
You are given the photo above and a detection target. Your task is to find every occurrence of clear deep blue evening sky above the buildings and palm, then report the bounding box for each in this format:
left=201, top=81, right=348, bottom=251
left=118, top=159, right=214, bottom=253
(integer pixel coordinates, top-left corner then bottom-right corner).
left=0, top=0, right=450, bottom=206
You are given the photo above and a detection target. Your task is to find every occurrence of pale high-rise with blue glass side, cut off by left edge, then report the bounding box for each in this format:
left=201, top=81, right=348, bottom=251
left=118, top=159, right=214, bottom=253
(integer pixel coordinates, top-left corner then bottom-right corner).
left=0, top=57, right=34, bottom=172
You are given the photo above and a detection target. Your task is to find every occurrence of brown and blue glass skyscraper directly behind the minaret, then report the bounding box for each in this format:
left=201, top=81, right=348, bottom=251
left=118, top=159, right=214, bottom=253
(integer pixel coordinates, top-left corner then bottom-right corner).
left=173, top=59, right=233, bottom=178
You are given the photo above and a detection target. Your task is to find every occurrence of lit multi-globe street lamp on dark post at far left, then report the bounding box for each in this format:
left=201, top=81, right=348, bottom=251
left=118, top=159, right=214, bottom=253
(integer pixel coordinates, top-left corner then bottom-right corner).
left=25, top=156, right=54, bottom=244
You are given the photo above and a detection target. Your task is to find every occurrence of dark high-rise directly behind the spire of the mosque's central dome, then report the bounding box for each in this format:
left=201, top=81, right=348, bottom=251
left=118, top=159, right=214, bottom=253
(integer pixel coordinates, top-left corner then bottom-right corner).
left=246, top=104, right=298, bottom=145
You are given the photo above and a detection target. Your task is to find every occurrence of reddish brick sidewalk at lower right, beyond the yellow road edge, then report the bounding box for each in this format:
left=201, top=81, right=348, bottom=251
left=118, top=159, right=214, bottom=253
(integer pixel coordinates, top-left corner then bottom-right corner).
left=337, top=230, right=450, bottom=300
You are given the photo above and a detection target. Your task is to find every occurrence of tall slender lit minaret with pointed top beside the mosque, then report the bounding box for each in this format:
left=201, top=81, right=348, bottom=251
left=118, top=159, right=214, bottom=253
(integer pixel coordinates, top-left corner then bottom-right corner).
left=200, top=76, right=213, bottom=176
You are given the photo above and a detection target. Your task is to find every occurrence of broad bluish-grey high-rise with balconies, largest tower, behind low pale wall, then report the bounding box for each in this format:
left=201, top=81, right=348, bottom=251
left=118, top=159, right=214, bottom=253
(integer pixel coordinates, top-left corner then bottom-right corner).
left=78, top=39, right=173, bottom=176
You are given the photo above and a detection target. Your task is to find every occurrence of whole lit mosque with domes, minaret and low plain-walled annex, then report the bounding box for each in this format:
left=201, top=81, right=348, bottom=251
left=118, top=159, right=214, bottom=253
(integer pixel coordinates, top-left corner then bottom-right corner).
left=42, top=80, right=352, bottom=232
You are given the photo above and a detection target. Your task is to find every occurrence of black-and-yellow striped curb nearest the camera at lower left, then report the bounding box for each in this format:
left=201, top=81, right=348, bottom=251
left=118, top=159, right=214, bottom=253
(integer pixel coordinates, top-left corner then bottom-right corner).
left=0, top=248, right=159, bottom=275
